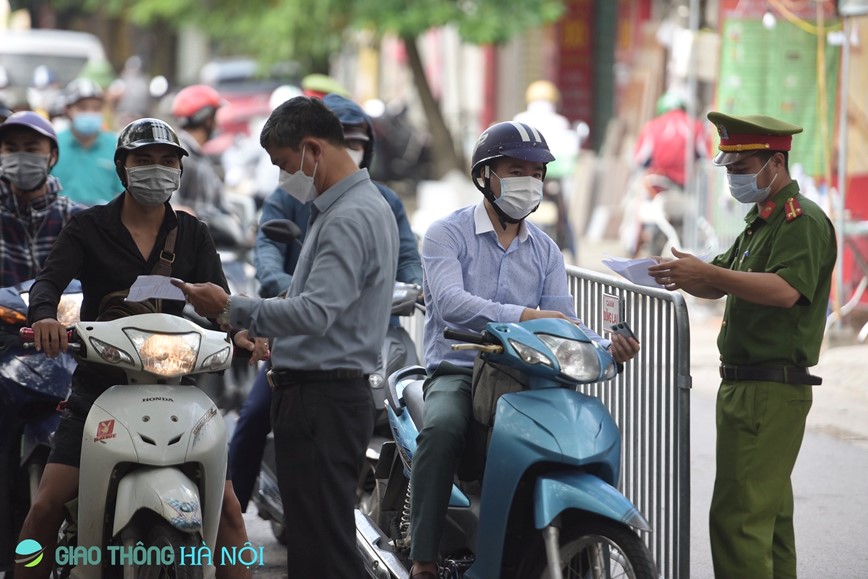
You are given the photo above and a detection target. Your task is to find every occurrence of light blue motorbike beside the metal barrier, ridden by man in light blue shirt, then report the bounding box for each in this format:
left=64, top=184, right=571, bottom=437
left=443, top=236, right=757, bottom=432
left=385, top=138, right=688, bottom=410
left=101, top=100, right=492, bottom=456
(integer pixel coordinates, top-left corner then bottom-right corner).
left=356, top=319, right=659, bottom=579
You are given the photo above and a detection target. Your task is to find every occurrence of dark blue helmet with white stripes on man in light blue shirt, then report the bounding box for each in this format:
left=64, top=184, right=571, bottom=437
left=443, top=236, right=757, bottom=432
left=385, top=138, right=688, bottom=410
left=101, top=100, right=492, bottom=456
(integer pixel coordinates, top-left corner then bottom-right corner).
left=470, top=121, right=555, bottom=223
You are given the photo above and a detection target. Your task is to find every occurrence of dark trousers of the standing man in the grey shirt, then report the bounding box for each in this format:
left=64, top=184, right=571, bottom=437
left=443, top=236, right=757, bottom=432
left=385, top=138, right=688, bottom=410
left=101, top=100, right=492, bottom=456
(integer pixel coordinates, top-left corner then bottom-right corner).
left=271, top=378, right=374, bottom=579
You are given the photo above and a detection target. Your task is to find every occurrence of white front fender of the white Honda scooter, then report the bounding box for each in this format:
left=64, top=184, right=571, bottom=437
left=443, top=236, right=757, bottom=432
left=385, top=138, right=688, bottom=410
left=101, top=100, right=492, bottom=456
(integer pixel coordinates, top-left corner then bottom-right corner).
left=112, top=467, right=202, bottom=536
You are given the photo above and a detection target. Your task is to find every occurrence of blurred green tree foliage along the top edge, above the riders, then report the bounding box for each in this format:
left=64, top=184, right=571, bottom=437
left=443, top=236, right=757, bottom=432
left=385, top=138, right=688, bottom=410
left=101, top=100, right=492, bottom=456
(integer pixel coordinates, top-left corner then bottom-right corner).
left=69, top=0, right=563, bottom=68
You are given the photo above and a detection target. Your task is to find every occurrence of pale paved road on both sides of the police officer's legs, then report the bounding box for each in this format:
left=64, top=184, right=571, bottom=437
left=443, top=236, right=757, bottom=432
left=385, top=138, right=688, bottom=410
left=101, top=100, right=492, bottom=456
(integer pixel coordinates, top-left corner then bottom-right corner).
left=688, top=302, right=868, bottom=579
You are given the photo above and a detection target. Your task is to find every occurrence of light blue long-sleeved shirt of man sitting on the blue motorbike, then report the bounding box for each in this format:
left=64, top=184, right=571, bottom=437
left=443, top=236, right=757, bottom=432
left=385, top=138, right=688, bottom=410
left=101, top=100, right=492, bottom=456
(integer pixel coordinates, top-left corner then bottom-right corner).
left=422, top=203, right=608, bottom=370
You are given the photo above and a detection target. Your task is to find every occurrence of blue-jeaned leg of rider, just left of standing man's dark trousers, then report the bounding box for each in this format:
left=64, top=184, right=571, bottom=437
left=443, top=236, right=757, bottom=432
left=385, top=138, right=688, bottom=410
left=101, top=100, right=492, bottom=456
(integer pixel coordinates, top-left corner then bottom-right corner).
left=229, top=364, right=271, bottom=512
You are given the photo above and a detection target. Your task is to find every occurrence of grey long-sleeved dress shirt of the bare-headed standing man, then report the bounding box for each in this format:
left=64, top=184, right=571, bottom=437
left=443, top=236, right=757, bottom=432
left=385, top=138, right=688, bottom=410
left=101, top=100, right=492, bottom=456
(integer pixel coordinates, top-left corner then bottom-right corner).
left=230, top=169, right=398, bottom=373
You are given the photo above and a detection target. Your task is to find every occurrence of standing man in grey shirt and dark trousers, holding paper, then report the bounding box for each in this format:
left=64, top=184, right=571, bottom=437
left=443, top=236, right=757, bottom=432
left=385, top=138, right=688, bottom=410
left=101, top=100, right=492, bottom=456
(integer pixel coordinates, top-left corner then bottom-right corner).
left=178, top=97, right=398, bottom=579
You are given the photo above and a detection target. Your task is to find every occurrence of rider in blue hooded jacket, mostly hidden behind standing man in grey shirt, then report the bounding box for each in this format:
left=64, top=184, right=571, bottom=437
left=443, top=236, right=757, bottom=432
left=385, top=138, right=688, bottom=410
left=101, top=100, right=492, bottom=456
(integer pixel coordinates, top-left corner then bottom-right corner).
left=229, top=93, right=422, bottom=511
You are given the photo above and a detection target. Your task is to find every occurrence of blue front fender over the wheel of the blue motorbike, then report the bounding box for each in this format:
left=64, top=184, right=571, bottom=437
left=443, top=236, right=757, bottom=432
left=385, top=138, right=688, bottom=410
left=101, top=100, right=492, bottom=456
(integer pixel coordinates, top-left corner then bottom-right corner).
left=533, top=471, right=651, bottom=531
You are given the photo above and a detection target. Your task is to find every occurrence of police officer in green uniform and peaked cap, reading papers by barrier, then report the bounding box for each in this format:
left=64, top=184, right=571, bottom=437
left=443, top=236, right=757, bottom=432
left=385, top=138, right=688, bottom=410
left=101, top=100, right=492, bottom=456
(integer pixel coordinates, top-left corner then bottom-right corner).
left=649, top=112, right=837, bottom=579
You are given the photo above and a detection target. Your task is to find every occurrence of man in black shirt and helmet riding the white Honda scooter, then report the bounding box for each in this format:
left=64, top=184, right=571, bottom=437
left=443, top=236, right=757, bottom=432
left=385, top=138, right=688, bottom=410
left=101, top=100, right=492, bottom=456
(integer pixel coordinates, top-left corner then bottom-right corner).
left=15, top=119, right=249, bottom=578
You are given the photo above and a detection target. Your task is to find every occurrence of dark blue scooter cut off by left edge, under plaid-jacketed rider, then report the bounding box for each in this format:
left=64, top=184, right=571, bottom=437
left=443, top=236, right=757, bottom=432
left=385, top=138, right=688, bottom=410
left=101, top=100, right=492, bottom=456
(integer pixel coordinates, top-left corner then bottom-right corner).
left=0, top=280, right=81, bottom=576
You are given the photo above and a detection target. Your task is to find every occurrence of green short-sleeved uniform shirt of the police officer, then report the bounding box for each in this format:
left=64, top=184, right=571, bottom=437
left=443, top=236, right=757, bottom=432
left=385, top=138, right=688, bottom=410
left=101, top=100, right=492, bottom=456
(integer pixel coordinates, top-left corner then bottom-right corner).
left=712, top=181, right=837, bottom=368
